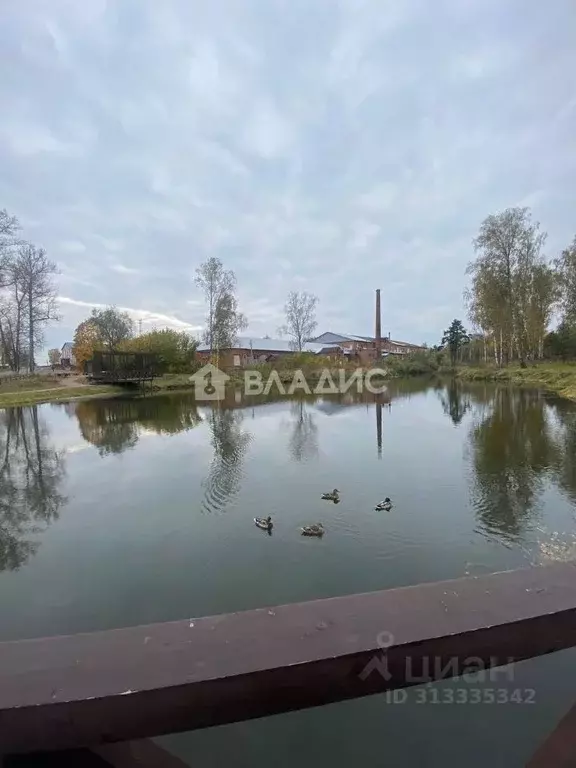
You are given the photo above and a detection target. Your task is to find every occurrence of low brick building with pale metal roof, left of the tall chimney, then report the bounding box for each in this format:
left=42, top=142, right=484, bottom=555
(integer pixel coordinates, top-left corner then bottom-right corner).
left=196, top=336, right=342, bottom=368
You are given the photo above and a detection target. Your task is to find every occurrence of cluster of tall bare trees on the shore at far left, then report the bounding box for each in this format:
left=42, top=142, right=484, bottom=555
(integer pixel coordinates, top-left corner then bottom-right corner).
left=0, top=210, right=58, bottom=373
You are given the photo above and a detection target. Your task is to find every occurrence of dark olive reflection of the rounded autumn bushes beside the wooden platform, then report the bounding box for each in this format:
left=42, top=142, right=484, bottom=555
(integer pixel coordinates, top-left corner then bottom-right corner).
left=76, top=395, right=201, bottom=456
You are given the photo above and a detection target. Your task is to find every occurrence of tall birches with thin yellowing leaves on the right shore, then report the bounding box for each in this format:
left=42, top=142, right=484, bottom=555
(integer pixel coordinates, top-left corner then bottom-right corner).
left=460, top=208, right=576, bottom=365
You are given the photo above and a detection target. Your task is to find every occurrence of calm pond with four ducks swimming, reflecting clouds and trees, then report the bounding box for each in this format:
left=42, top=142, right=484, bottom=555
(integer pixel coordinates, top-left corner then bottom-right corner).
left=0, top=380, right=576, bottom=766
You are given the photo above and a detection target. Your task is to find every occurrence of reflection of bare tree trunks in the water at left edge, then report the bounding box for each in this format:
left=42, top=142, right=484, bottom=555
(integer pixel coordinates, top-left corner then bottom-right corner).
left=0, top=406, right=66, bottom=570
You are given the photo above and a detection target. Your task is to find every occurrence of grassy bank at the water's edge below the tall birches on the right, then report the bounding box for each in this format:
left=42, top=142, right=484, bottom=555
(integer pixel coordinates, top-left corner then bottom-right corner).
left=456, top=362, right=576, bottom=400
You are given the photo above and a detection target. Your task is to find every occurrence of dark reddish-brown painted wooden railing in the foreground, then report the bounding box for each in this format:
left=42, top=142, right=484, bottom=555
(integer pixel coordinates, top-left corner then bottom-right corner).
left=0, top=563, right=576, bottom=768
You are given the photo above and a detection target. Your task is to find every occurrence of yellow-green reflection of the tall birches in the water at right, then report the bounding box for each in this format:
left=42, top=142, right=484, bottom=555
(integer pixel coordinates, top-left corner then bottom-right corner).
left=470, top=389, right=557, bottom=538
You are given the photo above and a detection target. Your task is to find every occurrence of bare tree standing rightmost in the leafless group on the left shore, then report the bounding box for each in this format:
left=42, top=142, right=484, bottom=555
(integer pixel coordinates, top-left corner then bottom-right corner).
left=15, top=243, right=58, bottom=373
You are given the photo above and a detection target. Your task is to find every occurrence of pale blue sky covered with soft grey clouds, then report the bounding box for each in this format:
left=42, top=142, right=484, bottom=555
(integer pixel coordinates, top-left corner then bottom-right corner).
left=0, top=0, right=576, bottom=354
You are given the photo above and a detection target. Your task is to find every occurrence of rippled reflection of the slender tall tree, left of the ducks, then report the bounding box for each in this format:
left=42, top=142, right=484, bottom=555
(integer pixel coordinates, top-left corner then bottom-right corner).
left=202, top=406, right=252, bottom=512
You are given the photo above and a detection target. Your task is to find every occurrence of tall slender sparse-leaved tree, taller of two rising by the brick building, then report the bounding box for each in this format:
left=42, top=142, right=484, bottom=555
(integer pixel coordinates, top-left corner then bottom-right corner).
left=196, top=256, right=248, bottom=351
